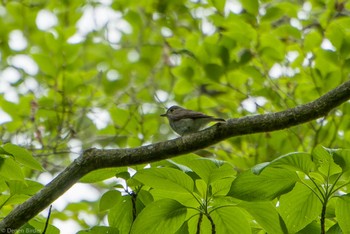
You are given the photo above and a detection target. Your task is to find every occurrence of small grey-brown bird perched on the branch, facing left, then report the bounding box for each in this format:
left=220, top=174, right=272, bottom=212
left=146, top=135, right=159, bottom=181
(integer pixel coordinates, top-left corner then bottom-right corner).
left=161, top=106, right=226, bottom=136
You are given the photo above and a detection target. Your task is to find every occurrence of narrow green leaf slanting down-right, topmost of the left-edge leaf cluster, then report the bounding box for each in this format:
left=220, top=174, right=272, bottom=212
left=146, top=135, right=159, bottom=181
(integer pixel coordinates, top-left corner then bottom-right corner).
left=2, top=143, right=44, bottom=171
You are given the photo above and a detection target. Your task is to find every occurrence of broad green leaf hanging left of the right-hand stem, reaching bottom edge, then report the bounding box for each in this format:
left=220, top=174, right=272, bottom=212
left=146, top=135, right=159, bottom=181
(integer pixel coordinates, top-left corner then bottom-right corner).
left=277, top=183, right=322, bottom=233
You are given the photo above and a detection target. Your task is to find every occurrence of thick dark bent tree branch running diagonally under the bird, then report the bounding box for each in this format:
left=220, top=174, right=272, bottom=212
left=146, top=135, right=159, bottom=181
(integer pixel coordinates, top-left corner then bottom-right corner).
left=0, top=81, right=350, bottom=233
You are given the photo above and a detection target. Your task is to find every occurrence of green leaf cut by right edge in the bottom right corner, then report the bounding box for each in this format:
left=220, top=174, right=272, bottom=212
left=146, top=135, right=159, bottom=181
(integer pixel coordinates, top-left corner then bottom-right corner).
left=335, top=194, right=350, bottom=233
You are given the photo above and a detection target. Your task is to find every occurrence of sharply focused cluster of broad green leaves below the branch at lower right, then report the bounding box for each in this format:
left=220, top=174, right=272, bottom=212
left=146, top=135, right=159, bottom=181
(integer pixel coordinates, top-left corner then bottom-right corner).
left=87, top=146, right=350, bottom=233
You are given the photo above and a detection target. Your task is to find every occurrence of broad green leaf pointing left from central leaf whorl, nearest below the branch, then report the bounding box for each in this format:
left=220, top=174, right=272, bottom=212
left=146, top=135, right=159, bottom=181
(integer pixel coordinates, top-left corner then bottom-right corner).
left=133, top=168, right=194, bottom=193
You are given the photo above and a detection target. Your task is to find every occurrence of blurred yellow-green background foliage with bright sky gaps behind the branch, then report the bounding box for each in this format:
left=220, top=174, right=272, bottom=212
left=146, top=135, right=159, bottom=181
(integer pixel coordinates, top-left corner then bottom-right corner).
left=0, top=0, right=350, bottom=230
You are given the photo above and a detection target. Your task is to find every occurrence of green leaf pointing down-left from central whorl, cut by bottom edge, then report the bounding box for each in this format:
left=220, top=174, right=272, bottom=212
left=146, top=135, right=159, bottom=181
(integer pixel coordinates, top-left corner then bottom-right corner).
left=131, top=199, right=187, bottom=234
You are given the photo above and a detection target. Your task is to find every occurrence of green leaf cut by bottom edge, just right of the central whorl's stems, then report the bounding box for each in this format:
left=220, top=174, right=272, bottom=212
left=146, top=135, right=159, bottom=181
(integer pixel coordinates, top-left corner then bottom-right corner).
left=239, top=202, right=288, bottom=234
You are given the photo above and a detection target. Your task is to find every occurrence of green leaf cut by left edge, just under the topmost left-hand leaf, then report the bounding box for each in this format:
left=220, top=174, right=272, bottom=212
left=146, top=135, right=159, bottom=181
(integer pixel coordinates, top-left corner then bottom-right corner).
left=0, top=158, right=24, bottom=181
